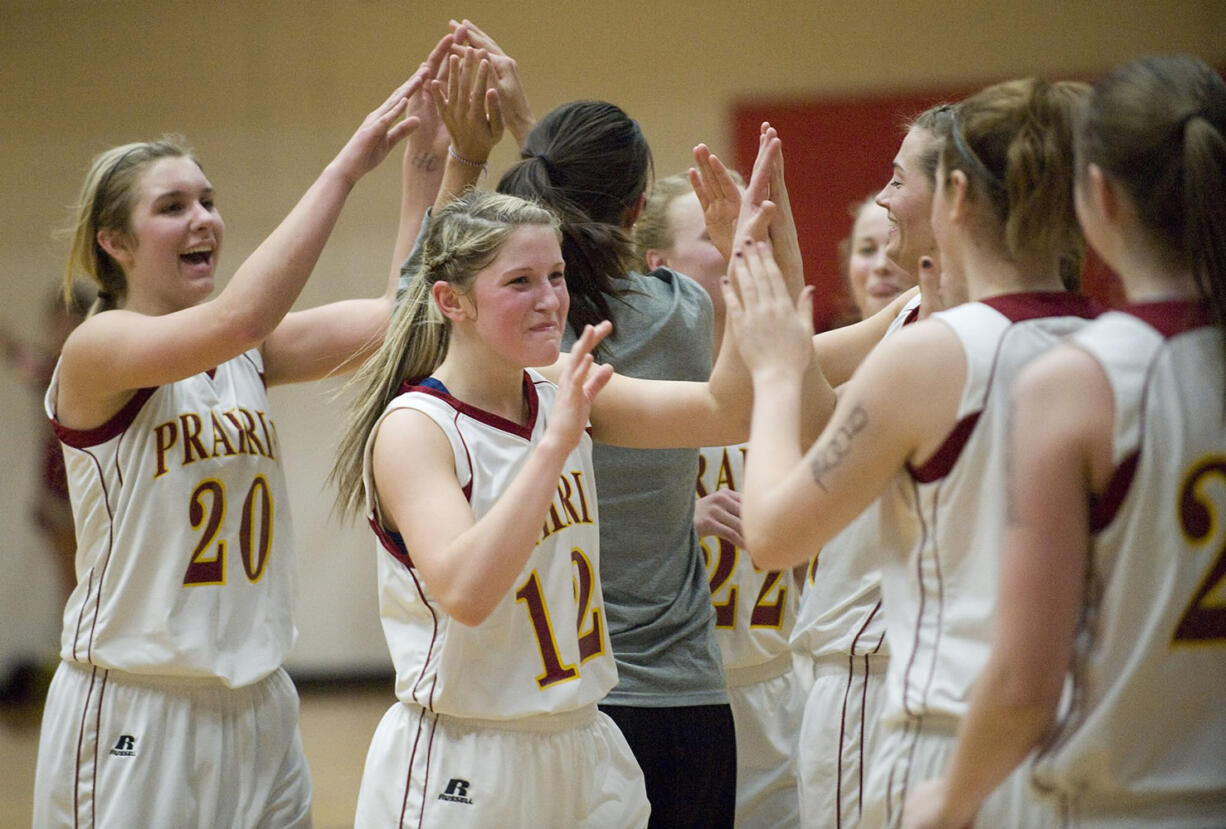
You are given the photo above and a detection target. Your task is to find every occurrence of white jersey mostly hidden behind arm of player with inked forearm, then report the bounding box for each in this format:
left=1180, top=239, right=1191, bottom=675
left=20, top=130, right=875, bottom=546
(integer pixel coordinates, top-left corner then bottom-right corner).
left=792, top=293, right=920, bottom=659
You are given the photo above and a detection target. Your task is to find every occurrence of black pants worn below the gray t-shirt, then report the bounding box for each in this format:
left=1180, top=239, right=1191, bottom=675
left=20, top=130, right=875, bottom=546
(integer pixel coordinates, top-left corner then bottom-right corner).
left=601, top=705, right=737, bottom=829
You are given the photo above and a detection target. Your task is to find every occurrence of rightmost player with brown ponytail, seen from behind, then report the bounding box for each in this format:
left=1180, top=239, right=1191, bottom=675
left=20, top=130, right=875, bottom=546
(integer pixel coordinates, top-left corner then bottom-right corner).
left=907, top=55, right=1226, bottom=827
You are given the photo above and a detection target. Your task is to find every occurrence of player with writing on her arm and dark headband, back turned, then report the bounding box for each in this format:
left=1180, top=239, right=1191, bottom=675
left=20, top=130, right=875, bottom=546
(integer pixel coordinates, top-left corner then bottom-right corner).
left=725, top=78, right=1092, bottom=827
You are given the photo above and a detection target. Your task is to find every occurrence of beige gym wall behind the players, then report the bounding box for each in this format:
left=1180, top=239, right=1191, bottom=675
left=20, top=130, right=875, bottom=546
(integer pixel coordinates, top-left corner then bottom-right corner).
left=0, top=0, right=1226, bottom=672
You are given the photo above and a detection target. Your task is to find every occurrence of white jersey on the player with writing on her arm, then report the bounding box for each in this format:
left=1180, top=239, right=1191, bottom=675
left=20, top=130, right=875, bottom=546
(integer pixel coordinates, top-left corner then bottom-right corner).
left=879, top=292, right=1094, bottom=722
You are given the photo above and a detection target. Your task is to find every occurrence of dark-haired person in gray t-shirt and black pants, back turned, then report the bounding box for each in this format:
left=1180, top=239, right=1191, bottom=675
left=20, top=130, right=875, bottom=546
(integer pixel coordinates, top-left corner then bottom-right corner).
left=498, top=101, right=737, bottom=827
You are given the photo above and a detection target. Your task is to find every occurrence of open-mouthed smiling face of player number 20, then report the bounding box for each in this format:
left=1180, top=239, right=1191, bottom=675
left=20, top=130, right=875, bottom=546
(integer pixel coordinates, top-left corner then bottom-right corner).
left=98, top=157, right=226, bottom=314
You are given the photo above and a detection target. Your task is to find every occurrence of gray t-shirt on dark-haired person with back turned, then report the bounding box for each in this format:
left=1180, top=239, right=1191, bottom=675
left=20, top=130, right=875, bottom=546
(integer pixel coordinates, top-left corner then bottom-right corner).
left=563, top=269, right=728, bottom=708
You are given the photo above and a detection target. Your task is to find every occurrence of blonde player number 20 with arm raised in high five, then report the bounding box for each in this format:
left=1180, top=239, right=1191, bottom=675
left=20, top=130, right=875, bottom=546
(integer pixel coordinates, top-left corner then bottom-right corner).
left=33, top=68, right=422, bottom=827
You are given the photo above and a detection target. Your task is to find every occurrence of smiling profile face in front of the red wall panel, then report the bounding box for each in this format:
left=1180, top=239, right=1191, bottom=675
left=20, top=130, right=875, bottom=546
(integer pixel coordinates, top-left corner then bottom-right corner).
left=877, top=126, right=937, bottom=273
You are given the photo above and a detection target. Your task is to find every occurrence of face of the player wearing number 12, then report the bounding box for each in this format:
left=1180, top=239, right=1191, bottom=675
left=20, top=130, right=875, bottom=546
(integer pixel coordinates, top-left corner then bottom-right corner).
left=459, top=224, right=570, bottom=367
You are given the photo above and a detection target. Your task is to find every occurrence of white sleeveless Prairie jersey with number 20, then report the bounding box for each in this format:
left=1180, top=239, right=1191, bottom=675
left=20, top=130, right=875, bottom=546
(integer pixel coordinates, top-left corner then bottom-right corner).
left=45, top=350, right=295, bottom=687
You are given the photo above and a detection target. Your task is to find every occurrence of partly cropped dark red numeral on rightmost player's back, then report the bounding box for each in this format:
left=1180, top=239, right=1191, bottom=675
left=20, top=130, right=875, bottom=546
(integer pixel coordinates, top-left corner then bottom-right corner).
left=1173, top=456, right=1226, bottom=643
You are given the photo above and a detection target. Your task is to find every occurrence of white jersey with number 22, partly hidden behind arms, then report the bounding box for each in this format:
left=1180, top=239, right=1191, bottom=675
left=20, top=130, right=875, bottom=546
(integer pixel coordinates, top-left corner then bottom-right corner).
left=698, top=444, right=797, bottom=670
